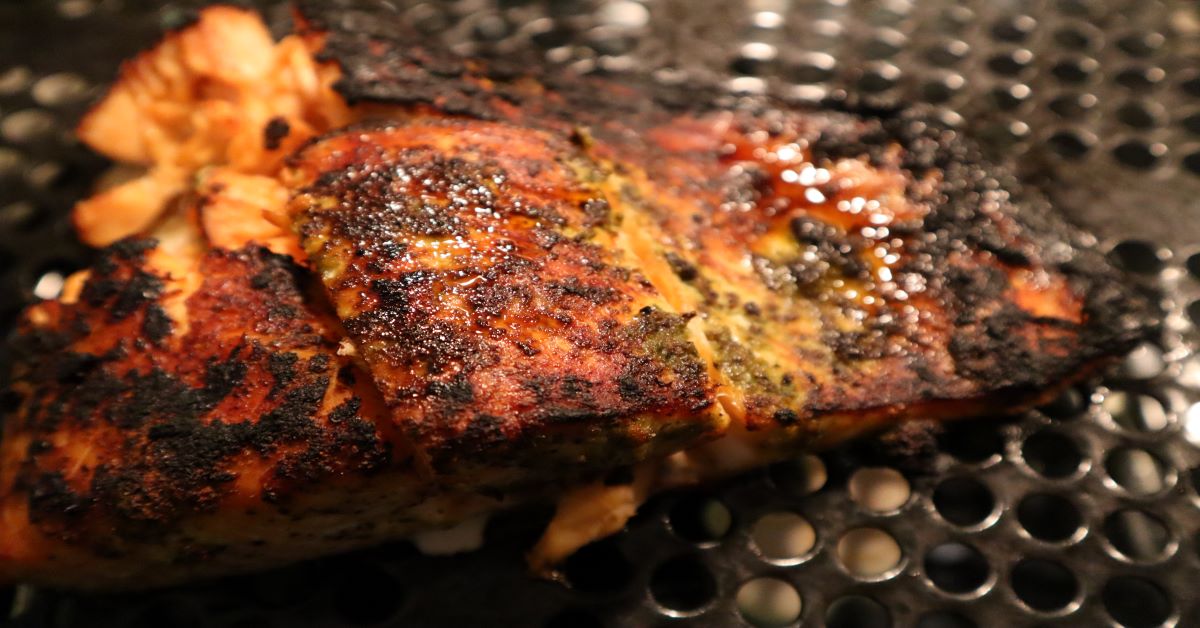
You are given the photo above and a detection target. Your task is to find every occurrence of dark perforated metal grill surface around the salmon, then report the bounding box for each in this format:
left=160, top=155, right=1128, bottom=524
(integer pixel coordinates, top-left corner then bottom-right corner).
left=0, top=0, right=1200, bottom=628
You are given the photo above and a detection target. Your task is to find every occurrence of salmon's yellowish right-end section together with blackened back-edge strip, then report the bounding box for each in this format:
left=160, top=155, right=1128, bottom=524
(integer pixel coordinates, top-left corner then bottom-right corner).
left=300, top=1, right=1153, bottom=447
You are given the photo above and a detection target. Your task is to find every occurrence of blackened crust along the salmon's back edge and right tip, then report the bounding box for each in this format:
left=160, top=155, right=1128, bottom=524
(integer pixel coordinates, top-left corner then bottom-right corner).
left=301, top=2, right=1153, bottom=427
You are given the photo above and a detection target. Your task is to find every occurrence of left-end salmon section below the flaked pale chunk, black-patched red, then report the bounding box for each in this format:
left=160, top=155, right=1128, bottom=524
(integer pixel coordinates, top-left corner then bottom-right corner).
left=0, top=240, right=429, bottom=582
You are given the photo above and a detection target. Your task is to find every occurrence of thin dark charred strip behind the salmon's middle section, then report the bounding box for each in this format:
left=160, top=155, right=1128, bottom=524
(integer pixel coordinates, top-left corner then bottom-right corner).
left=296, top=0, right=722, bottom=132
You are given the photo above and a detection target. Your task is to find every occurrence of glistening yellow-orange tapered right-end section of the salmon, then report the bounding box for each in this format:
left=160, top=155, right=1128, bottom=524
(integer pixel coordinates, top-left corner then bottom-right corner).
left=604, top=108, right=1152, bottom=444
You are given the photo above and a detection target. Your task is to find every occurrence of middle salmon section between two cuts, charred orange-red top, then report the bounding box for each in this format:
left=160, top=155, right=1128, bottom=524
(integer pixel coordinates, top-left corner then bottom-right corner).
left=283, top=119, right=726, bottom=490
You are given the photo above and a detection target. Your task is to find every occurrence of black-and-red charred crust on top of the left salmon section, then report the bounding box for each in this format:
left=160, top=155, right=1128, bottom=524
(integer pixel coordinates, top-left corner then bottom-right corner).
left=10, top=243, right=390, bottom=545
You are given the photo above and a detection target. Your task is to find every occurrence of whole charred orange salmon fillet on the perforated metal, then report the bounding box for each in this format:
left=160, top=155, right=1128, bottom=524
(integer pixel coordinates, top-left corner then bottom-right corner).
left=0, top=2, right=1151, bottom=588
